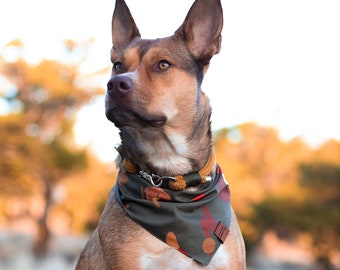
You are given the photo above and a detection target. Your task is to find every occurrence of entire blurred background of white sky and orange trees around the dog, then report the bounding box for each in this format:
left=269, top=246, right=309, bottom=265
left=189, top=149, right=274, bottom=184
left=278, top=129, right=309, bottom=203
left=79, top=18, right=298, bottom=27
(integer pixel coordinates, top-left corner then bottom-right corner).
left=0, top=0, right=340, bottom=270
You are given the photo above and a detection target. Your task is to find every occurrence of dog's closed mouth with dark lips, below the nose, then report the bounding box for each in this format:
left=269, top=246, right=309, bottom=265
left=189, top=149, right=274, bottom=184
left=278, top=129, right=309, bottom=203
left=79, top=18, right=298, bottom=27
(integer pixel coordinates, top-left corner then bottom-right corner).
left=105, top=107, right=167, bottom=128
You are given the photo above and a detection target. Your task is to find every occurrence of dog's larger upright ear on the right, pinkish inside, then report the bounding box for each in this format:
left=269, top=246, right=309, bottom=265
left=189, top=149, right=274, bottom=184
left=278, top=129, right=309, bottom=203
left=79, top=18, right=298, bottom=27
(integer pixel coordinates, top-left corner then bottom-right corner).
left=175, top=0, right=223, bottom=64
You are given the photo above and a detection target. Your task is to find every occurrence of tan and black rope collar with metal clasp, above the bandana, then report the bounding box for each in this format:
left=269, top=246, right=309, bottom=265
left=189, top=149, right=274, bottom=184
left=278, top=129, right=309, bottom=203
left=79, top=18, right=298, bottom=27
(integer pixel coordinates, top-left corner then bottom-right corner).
left=116, top=145, right=215, bottom=191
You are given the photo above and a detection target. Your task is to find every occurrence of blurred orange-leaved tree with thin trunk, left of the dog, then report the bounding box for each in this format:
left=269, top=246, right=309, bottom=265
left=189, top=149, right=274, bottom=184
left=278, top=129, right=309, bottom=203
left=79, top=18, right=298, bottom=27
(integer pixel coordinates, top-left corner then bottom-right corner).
left=0, top=41, right=102, bottom=254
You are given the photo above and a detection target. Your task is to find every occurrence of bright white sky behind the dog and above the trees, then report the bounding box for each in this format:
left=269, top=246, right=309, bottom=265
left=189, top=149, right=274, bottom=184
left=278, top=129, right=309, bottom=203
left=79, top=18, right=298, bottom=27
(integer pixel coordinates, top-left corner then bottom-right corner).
left=0, top=0, right=340, bottom=161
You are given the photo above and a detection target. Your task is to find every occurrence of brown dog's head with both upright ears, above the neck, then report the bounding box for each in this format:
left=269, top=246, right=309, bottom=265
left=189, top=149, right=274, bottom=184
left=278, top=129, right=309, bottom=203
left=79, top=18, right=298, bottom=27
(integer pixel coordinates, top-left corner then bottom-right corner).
left=106, top=0, right=223, bottom=175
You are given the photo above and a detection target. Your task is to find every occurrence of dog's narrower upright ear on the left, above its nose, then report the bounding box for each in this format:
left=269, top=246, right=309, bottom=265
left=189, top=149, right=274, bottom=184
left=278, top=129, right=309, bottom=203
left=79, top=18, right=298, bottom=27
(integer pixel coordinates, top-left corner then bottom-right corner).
left=112, top=0, right=140, bottom=52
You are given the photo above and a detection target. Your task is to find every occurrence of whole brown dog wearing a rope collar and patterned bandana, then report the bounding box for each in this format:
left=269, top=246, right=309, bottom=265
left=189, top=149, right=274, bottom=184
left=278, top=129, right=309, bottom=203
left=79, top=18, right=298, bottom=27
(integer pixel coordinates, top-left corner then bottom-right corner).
left=76, top=0, right=246, bottom=270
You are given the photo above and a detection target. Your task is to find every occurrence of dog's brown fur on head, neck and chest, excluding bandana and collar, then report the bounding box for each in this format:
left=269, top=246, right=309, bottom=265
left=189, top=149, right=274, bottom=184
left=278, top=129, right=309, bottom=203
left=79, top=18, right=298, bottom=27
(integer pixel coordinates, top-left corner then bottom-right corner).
left=76, top=0, right=246, bottom=270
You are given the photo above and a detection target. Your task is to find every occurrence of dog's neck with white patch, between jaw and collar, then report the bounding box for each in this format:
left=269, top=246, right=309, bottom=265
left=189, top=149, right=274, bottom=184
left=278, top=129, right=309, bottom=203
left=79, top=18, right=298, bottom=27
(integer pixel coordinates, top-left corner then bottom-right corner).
left=120, top=92, right=212, bottom=176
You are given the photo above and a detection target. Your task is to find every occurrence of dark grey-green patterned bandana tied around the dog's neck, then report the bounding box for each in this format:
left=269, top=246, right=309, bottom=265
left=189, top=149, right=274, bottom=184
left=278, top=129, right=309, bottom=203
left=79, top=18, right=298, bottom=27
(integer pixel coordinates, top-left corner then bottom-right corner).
left=114, top=166, right=231, bottom=265
